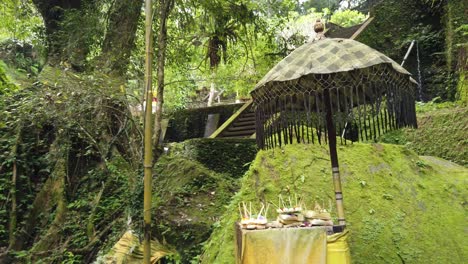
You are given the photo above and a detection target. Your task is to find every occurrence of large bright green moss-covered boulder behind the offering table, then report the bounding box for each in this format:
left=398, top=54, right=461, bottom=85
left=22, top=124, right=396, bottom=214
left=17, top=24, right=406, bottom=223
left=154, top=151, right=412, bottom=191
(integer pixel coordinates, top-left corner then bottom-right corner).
left=202, top=144, right=468, bottom=263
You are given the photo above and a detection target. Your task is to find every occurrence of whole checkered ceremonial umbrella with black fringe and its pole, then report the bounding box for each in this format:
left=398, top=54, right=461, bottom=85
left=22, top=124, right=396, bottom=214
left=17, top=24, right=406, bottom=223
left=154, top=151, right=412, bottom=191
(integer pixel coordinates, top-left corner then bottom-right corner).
left=251, top=38, right=416, bottom=227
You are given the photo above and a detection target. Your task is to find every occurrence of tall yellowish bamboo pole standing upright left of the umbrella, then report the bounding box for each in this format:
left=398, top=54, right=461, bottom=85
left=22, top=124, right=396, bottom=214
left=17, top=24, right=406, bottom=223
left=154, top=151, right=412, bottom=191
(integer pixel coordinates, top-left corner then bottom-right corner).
left=143, top=0, right=153, bottom=264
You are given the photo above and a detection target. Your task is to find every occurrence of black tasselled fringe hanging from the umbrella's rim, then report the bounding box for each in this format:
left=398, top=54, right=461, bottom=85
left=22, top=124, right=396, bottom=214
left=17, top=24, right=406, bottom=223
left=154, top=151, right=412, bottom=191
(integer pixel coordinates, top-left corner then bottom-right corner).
left=254, top=72, right=417, bottom=149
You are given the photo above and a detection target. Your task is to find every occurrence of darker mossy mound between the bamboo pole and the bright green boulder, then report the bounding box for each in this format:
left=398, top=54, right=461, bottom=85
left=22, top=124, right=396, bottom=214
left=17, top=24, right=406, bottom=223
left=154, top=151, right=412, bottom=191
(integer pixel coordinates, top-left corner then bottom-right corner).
left=153, top=155, right=238, bottom=263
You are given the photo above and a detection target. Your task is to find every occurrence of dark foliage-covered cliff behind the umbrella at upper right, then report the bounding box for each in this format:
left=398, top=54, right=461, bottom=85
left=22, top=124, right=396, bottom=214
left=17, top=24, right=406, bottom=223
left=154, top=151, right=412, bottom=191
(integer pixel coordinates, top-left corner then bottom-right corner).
left=358, top=0, right=468, bottom=101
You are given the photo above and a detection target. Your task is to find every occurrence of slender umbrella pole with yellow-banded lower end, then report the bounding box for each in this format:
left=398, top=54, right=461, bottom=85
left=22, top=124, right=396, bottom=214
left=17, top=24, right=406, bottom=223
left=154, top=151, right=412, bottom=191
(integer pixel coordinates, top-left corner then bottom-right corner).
left=324, top=89, right=346, bottom=225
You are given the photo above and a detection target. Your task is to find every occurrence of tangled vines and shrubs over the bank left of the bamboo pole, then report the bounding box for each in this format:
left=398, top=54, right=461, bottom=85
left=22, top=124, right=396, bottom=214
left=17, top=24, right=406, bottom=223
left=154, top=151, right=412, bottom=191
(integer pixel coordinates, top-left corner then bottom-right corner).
left=0, top=64, right=140, bottom=262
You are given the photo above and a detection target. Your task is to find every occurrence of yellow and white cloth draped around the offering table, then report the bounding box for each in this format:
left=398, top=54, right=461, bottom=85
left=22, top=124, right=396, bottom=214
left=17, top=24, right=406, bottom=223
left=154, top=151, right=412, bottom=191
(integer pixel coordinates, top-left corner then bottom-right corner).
left=236, top=227, right=327, bottom=264
